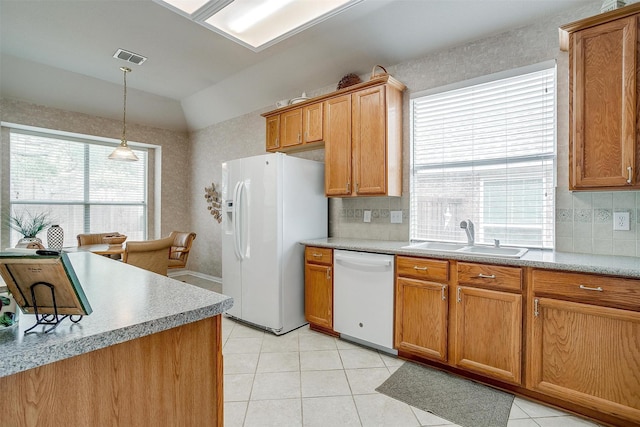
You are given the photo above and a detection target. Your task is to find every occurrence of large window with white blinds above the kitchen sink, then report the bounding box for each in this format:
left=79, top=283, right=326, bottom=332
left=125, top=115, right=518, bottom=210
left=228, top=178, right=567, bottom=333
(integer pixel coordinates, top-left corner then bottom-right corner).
left=410, top=65, right=556, bottom=248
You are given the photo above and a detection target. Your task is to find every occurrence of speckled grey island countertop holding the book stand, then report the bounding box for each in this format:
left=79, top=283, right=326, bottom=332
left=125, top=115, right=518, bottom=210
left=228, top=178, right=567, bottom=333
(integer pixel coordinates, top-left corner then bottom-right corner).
left=0, top=252, right=233, bottom=377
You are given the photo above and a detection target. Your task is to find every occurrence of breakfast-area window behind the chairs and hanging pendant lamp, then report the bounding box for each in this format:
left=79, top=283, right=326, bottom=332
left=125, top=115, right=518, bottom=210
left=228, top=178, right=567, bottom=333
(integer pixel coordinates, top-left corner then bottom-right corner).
left=9, top=129, right=148, bottom=246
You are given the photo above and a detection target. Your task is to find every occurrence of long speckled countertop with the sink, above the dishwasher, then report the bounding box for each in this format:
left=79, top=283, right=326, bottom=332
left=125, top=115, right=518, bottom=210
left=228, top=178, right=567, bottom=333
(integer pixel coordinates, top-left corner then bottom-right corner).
left=300, top=237, right=640, bottom=278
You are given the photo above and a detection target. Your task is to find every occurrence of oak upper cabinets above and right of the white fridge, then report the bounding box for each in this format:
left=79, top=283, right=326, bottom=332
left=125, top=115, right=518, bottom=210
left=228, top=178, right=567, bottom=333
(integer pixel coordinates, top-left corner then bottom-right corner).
left=263, top=75, right=405, bottom=197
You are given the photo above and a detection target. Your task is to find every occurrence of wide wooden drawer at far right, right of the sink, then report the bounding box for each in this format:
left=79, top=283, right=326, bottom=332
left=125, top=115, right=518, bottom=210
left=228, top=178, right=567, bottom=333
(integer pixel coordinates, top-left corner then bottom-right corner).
left=533, top=270, right=640, bottom=311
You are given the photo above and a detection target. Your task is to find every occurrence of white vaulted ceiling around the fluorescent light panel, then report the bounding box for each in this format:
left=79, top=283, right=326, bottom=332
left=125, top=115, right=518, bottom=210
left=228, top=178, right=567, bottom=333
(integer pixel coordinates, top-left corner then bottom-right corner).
left=0, top=0, right=594, bottom=131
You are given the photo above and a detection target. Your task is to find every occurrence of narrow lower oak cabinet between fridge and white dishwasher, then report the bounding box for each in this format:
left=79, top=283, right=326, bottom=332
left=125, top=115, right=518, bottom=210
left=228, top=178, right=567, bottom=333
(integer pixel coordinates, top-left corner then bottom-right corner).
left=304, top=247, right=333, bottom=329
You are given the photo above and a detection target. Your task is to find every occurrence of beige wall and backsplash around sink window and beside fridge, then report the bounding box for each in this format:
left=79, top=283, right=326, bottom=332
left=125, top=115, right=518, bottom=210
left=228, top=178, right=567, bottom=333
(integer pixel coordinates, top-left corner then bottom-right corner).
left=190, top=1, right=640, bottom=276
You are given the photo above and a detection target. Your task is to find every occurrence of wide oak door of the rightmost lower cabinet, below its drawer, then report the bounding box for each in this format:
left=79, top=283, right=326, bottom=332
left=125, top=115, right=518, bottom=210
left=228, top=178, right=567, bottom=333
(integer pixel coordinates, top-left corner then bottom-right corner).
left=528, top=298, right=640, bottom=422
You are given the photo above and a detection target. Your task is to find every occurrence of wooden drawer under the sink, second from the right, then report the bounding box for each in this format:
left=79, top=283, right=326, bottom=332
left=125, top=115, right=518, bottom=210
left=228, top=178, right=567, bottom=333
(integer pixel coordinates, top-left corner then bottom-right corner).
left=458, top=262, right=522, bottom=291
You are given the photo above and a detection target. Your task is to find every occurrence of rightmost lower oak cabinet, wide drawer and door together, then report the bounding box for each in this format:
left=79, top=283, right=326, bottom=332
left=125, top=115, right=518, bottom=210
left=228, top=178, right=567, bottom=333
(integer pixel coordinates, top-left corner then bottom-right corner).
left=526, top=269, right=640, bottom=425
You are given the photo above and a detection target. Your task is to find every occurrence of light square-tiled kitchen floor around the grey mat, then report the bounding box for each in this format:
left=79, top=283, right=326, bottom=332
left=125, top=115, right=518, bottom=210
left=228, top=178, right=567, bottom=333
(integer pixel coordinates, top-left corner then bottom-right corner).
left=222, top=317, right=597, bottom=427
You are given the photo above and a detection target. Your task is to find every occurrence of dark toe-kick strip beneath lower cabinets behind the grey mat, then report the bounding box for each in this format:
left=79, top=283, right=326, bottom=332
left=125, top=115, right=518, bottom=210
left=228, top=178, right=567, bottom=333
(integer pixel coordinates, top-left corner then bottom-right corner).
left=398, top=350, right=640, bottom=427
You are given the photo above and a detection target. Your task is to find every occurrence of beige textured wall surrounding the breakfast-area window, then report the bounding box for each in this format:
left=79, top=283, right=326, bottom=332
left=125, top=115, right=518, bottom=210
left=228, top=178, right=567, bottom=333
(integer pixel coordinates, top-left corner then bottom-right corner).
left=0, top=99, right=191, bottom=247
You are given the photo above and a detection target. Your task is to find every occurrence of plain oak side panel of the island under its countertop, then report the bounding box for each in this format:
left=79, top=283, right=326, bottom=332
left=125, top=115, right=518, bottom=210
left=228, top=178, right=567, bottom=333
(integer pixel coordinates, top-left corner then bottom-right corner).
left=0, top=316, right=223, bottom=426
